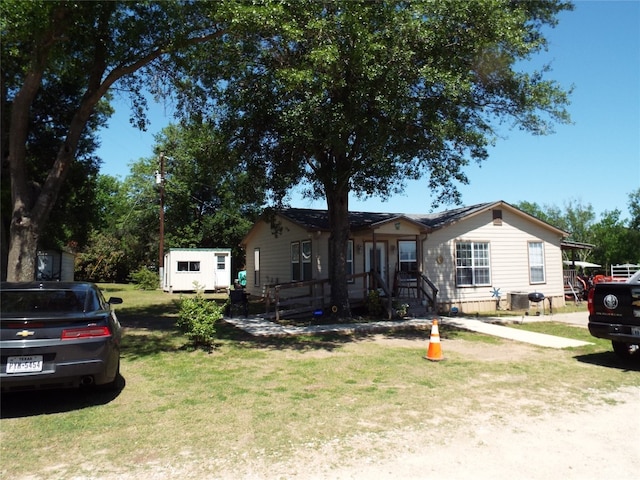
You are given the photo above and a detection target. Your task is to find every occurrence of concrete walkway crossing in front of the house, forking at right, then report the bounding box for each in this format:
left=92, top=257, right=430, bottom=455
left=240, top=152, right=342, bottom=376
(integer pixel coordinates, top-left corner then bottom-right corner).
left=224, top=313, right=590, bottom=348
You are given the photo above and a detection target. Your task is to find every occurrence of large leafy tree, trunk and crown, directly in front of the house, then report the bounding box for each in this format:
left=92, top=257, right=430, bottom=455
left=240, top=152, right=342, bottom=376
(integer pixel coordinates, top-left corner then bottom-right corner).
left=194, top=0, right=571, bottom=317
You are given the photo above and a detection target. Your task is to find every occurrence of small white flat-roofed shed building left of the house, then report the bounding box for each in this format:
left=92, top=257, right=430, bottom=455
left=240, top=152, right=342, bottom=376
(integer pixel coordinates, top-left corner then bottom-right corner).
left=162, top=248, right=231, bottom=292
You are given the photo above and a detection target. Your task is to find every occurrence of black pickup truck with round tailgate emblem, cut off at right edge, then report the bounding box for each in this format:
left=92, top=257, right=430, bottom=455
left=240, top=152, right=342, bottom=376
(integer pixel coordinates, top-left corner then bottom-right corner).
left=587, top=271, right=640, bottom=361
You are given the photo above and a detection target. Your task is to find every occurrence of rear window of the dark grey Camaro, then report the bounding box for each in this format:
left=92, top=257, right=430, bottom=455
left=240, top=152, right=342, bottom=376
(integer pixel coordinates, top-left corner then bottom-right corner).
left=0, top=290, right=87, bottom=313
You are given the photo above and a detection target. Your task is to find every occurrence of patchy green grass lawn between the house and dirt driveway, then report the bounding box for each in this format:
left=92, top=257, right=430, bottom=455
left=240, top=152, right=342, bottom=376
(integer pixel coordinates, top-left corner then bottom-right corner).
left=0, top=285, right=640, bottom=479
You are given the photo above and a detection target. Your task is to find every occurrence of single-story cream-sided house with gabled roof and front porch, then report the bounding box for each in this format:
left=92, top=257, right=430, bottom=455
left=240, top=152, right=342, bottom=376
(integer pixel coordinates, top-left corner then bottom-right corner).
left=242, top=201, right=568, bottom=313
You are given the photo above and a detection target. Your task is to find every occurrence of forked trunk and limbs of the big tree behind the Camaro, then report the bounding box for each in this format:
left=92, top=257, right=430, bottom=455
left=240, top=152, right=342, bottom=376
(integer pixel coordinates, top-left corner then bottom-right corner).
left=2, top=2, right=225, bottom=281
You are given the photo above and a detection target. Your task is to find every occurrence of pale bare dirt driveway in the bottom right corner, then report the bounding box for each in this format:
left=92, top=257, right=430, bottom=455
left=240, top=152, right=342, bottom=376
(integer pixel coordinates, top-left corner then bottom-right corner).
left=294, top=388, right=640, bottom=480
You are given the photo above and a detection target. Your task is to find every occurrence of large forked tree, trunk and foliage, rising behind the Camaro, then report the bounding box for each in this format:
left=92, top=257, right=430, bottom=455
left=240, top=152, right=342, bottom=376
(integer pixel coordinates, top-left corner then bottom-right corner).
left=0, top=0, right=222, bottom=281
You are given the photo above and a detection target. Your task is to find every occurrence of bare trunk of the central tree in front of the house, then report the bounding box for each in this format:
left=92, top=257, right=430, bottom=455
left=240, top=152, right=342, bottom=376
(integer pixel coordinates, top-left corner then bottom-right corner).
left=326, top=189, right=351, bottom=319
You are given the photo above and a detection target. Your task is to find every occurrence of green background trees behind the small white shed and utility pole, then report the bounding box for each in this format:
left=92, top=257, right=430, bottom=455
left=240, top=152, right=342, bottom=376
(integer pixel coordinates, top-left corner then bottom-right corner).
left=76, top=124, right=264, bottom=282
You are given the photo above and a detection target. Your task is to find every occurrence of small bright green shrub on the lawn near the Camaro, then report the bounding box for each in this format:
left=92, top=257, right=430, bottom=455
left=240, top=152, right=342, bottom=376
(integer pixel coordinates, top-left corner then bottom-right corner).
left=176, top=291, right=224, bottom=346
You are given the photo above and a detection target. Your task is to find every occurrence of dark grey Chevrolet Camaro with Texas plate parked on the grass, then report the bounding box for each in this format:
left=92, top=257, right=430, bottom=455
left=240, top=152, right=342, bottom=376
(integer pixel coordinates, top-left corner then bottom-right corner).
left=0, top=282, right=122, bottom=392
